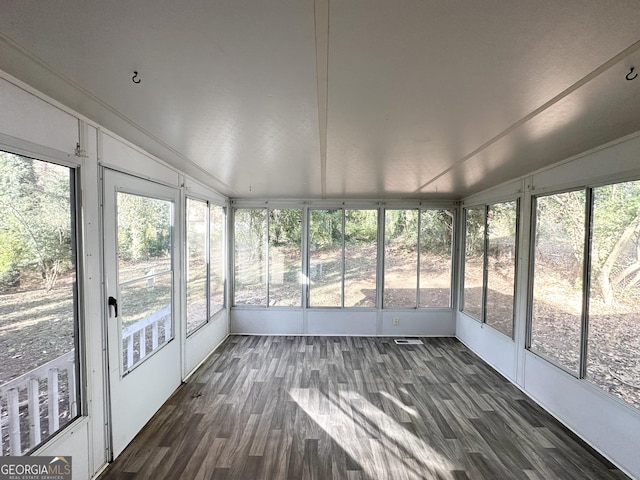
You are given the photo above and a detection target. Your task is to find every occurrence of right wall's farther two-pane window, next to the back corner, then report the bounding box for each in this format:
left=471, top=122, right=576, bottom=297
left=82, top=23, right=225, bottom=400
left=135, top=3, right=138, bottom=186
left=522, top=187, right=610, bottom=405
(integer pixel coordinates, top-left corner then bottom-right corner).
left=462, top=201, right=518, bottom=338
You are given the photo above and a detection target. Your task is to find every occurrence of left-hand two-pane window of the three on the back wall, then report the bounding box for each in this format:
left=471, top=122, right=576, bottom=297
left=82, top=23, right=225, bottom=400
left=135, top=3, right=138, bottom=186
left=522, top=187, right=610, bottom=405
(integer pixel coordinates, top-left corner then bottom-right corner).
left=234, top=208, right=302, bottom=306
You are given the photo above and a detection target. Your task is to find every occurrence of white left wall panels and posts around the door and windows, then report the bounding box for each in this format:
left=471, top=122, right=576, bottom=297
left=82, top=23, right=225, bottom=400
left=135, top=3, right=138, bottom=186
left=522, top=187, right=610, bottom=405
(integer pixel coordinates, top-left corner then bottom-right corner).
left=0, top=72, right=229, bottom=480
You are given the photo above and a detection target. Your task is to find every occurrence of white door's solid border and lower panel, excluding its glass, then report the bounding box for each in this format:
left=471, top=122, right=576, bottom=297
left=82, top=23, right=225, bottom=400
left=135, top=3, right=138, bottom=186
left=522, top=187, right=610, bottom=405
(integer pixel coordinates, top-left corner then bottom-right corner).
left=100, top=167, right=185, bottom=461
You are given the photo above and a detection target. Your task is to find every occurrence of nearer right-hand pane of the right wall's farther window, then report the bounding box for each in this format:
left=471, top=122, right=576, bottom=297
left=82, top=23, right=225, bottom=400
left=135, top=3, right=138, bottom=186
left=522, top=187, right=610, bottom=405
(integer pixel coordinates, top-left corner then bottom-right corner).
left=485, top=202, right=518, bottom=337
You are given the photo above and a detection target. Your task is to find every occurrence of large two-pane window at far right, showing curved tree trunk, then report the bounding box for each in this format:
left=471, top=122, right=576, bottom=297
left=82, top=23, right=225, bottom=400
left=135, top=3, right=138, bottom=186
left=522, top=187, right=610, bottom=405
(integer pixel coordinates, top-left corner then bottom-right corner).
left=530, top=181, right=640, bottom=407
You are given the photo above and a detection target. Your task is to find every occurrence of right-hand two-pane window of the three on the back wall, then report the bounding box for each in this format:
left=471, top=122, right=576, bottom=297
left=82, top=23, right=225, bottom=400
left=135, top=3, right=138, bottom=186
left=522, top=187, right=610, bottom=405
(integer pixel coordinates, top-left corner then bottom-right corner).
left=383, top=209, right=454, bottom=308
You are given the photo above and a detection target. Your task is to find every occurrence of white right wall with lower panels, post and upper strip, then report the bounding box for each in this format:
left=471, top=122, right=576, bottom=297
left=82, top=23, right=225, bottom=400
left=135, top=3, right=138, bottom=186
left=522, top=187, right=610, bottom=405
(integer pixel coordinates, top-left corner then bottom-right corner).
left=456, top=134, right=640, bottom=478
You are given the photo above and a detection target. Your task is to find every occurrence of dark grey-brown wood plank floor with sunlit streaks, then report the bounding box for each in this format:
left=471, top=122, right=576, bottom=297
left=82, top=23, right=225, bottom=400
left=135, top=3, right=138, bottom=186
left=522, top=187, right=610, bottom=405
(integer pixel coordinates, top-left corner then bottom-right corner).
left=100, top=336, right=627, bottom=480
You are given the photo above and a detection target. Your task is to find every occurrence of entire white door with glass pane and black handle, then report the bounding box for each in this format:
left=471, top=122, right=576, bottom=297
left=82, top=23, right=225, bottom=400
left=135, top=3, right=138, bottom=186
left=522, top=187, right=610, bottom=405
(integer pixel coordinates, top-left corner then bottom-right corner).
left=103, top=169, right=181, bottom=458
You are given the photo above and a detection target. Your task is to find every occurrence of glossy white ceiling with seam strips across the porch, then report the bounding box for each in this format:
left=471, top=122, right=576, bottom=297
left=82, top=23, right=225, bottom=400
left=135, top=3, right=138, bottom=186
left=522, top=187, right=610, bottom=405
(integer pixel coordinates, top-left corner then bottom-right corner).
left=0, top=0, right=640, bottom=199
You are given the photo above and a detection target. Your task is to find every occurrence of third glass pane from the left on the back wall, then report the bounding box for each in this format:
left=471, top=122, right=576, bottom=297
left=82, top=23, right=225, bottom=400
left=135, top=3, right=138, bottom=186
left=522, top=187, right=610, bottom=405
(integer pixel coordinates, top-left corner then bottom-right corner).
left=309, top=209, right=342, bottom=307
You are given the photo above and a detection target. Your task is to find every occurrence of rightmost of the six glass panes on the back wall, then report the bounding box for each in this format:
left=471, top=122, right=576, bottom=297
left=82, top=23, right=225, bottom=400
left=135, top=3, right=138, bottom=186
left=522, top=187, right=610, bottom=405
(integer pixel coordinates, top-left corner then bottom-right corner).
left=420, top=210, right=453, bottom=308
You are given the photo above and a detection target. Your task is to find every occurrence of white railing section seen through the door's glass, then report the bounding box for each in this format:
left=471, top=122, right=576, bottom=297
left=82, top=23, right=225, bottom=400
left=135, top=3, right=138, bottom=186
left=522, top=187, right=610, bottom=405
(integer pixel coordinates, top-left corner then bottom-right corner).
left=122, top=304, right=171, bottom=371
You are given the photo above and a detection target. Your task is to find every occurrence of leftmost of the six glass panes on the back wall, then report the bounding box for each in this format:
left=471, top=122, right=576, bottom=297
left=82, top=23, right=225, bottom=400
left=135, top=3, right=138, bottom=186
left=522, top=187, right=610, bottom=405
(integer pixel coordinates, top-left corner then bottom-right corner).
left=234, top=208, right=267, bottom=305
